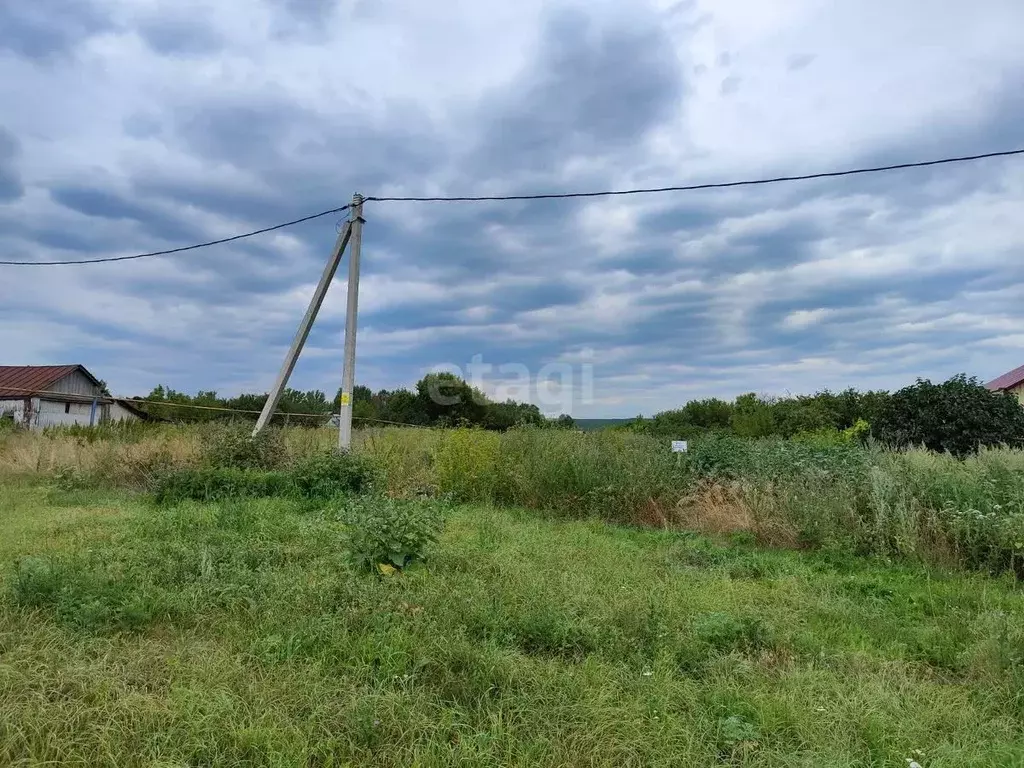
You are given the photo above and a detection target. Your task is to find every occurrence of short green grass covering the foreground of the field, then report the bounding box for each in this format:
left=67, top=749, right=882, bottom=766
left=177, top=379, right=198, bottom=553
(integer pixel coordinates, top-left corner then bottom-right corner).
left=0, top=481, right=1024, bottom=768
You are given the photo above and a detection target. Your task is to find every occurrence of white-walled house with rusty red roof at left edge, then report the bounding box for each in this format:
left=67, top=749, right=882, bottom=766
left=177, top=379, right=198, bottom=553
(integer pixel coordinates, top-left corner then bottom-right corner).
left=0, top=366, right=146, bottom=429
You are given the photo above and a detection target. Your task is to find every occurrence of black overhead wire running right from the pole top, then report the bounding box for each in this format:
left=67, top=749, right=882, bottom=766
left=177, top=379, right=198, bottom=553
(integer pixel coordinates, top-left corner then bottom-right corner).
left=366, top=148, right=1024, bottom=203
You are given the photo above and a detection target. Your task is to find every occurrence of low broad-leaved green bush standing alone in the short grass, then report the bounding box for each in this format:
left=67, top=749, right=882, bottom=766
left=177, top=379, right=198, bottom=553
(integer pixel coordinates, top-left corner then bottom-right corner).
left=341, top=497, right=444, bottom=570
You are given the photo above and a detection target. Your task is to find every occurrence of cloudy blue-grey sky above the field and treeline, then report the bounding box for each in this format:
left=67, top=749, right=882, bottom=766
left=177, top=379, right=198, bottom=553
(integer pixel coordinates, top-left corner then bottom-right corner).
left=0, top=0, right=1024, bottom=418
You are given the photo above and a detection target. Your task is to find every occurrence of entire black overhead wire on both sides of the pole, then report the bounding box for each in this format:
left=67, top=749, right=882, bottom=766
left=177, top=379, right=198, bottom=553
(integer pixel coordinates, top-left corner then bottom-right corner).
left=0, top=147, right=1024, bottom=266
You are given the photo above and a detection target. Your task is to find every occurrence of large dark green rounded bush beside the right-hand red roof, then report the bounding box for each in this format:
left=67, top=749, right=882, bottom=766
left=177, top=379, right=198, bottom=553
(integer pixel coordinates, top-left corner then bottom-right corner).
left=872, top=374, right=1024, bottom=457
